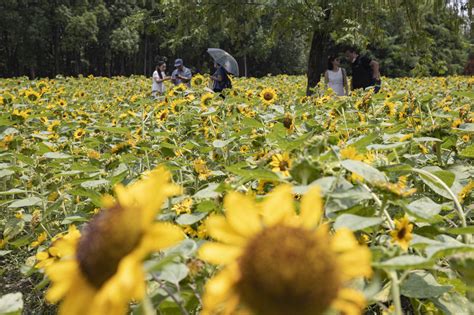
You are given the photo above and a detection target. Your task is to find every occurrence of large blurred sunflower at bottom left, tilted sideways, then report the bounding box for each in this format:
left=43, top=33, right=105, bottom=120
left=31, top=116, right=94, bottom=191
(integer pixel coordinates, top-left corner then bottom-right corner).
left=46, top=168, right=184, bottom=315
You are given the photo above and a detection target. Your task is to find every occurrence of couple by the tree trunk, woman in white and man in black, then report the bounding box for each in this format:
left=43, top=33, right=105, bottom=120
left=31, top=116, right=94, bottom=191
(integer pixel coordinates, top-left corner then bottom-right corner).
left=324, top=48, right=382, bottom=96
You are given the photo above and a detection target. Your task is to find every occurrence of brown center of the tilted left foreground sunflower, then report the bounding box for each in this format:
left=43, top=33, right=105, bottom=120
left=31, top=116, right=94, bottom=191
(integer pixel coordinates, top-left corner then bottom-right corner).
left=77, top=204, right=141, bottom=289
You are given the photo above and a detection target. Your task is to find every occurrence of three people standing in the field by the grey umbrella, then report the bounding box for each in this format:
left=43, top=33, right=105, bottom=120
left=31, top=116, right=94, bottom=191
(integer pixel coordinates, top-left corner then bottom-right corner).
left=151, top=58, right=232, bottom=97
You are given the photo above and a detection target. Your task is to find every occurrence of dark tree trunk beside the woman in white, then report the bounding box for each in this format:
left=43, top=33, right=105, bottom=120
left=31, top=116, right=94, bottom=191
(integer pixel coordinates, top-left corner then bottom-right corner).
left=306, top=28, right=330, bottom=95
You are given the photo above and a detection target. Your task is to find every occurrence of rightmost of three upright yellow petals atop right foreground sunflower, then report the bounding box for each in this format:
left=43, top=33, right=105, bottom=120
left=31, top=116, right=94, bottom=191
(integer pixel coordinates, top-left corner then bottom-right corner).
left=300, top=186, right=323, bottom=228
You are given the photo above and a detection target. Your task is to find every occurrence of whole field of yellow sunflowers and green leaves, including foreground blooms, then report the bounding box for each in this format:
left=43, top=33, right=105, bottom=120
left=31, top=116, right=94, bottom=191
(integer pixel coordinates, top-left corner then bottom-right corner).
left=0, top=75, right=474, bottom=315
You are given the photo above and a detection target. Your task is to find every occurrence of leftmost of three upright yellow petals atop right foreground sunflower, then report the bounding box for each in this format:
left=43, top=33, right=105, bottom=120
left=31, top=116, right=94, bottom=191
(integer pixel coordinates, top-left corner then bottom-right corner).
left=224, top=192, right=261, bottom=237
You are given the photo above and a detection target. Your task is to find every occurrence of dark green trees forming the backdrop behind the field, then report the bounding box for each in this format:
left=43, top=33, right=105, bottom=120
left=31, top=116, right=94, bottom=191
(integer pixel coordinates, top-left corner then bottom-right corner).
left=0, top=0, right=474, bottom=81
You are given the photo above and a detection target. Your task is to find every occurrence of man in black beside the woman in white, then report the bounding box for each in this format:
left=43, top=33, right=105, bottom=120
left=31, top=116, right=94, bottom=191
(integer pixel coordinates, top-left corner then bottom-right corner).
left=346, top=48, right=382, bottom=93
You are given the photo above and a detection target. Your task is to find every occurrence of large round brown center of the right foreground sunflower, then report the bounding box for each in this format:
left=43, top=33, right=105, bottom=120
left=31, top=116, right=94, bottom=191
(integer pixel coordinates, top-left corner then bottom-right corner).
left=237, top=225, right=341, bottom=315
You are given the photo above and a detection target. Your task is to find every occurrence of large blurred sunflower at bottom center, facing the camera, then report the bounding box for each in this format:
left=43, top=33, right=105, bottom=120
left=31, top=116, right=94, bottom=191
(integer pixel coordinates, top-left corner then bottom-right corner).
left=199, top=185, right=372, bottom=315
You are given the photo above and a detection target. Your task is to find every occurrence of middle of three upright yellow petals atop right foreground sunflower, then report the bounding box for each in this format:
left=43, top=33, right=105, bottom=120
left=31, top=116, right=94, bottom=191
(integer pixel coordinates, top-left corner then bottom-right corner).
left=262, top=185, right=294, bottom=226
